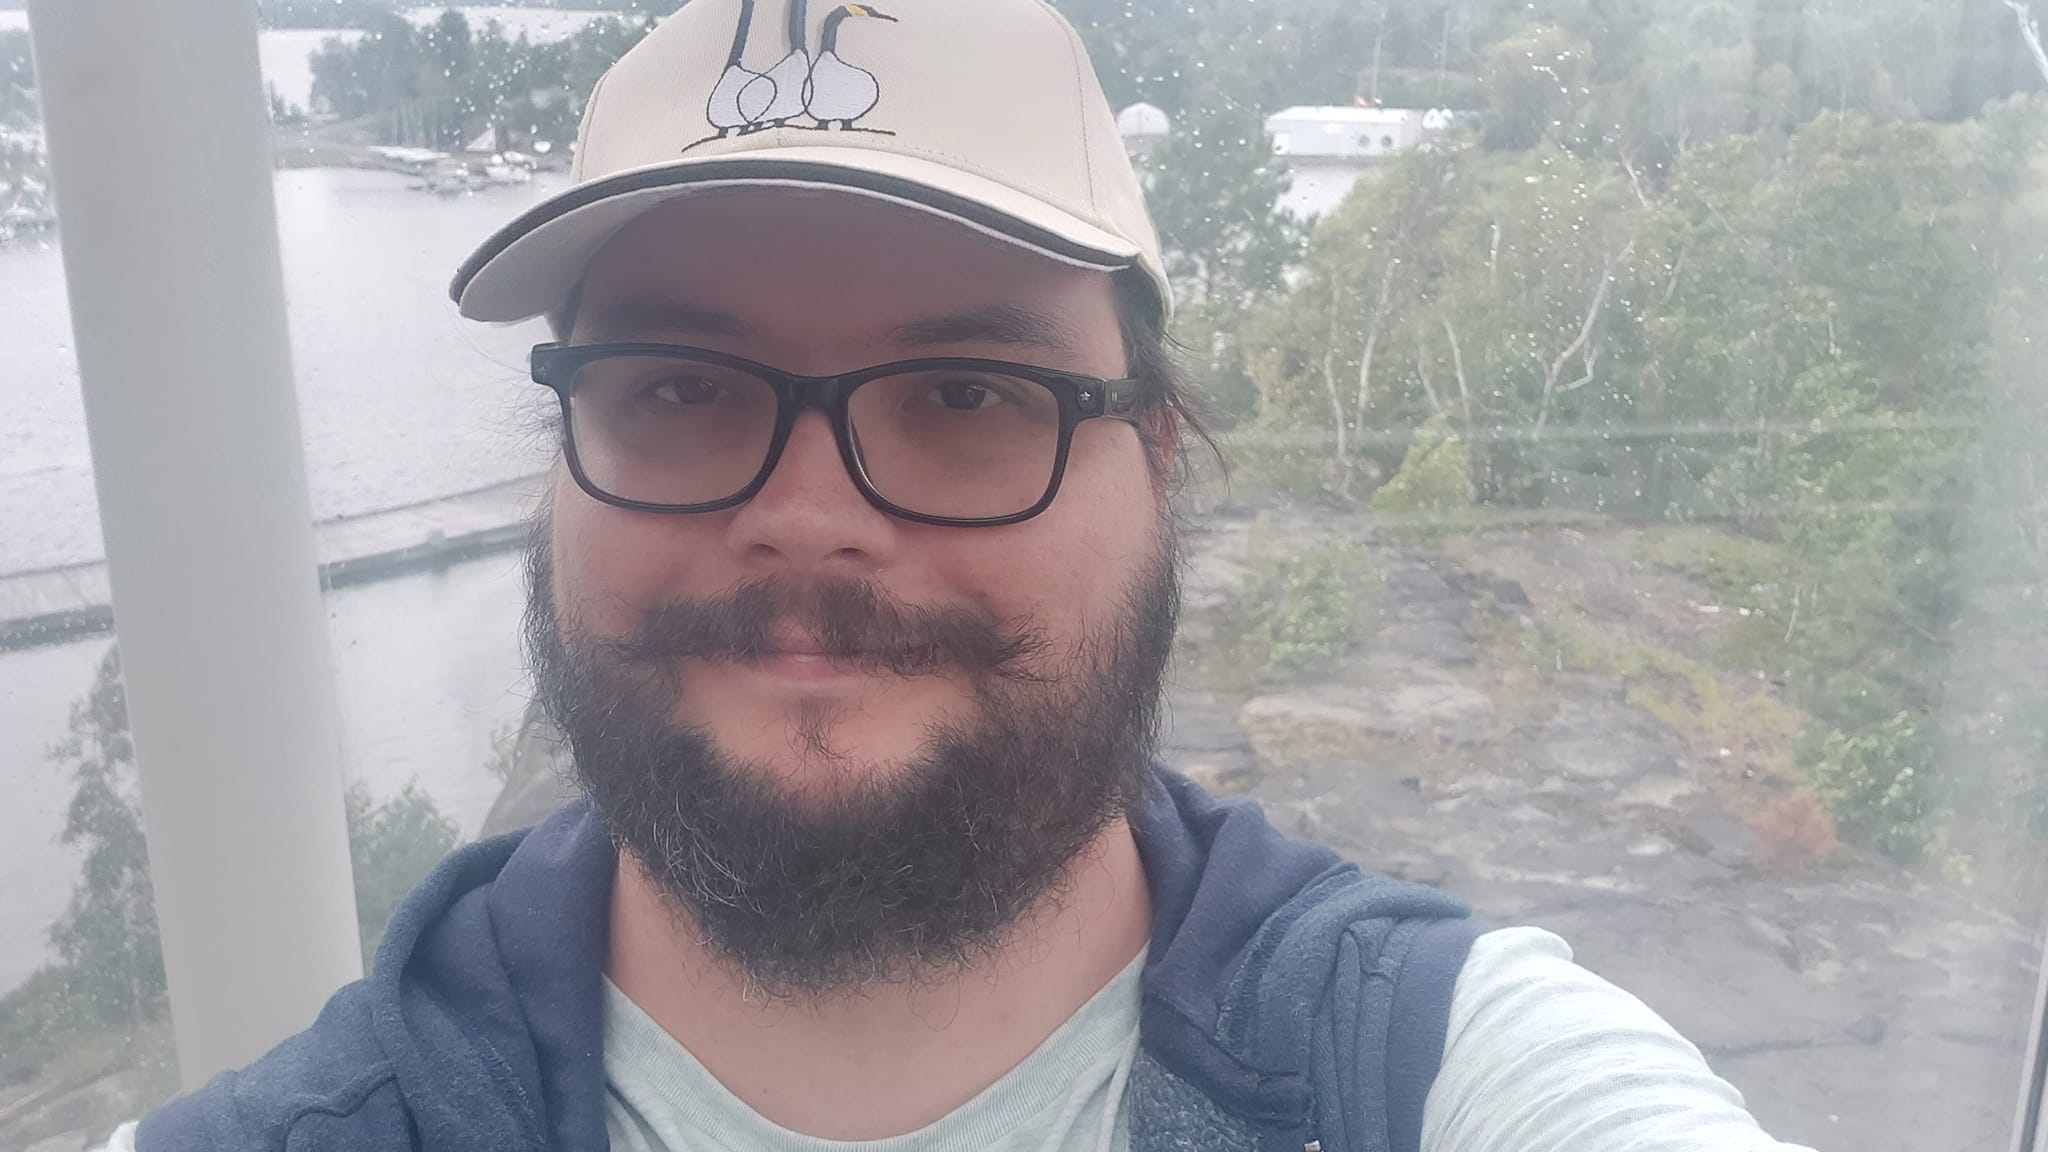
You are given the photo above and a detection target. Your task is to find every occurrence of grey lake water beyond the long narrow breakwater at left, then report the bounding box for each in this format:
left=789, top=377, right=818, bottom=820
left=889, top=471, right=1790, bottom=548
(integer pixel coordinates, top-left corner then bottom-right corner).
left=0, top=168, right=559, bottom=572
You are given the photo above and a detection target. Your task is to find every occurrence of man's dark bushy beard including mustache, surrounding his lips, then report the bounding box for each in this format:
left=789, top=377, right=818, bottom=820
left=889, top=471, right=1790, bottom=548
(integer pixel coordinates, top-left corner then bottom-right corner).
left=526, top=508, right=1180, bottom=998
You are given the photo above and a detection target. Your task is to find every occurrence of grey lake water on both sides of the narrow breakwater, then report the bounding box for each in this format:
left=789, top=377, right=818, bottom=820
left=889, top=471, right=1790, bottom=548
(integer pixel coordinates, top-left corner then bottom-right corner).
left=0, top=170, right=559, bottom=990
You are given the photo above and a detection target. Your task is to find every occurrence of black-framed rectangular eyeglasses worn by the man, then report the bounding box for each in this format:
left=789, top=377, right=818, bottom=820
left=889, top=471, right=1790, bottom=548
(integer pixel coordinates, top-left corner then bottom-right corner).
left=532, top=344, right=1139, bottom=527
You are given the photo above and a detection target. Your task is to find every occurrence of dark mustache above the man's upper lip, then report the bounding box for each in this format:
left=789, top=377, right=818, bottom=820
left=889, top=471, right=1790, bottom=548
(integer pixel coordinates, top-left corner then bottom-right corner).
left=608, top=578, right=1049, bottom=681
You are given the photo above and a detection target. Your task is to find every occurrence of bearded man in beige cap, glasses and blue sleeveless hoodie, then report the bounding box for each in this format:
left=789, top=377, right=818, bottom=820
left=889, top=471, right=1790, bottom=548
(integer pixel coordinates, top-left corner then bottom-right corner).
left=121, top=0, right=1810, bottom=1152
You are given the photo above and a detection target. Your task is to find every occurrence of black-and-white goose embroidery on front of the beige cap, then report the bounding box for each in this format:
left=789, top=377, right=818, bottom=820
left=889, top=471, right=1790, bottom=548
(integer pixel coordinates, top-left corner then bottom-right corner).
left=684, top=0, right=897, bottom=152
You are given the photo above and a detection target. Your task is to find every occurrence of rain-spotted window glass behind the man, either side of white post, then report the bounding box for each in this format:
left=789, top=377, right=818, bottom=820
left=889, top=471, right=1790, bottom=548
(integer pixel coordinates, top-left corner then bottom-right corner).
left=0, top=0, right=2048, bottom=1152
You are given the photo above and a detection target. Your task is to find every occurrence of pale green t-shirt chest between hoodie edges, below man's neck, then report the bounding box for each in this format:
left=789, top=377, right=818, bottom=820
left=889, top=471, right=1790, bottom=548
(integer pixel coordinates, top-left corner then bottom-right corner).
left=604, top=951, right=1145, bottom=1152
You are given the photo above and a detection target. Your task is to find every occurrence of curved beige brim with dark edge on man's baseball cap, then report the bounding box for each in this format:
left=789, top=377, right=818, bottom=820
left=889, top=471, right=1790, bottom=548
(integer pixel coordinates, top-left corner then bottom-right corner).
left=449, top=148, right=1157, bottom=322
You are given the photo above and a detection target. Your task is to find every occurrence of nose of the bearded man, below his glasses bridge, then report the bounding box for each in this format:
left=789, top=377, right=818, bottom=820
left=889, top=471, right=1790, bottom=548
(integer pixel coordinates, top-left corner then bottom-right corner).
left=729, top=410, right=899, bottom=574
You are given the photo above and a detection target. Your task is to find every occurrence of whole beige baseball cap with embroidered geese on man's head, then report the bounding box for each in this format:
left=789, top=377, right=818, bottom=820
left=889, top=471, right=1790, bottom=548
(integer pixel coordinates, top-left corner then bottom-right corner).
left=449, top=0, right=1171, bottom=320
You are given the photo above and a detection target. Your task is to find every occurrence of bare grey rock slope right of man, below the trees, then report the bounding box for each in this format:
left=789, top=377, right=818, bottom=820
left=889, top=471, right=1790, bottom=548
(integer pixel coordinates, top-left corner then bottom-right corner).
left=1174, top=508, right=2040, bottom=1152
